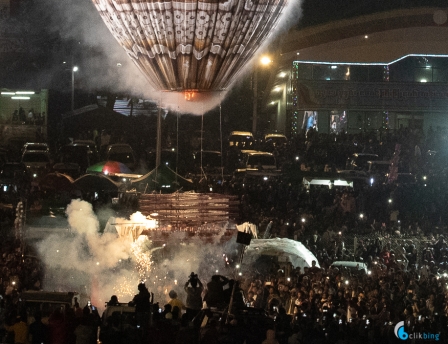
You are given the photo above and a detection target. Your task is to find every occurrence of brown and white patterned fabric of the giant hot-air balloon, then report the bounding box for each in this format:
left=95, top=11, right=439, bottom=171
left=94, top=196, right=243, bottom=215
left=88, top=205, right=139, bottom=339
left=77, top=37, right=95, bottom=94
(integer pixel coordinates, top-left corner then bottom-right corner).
left=92, top=0, right=287, bottom=91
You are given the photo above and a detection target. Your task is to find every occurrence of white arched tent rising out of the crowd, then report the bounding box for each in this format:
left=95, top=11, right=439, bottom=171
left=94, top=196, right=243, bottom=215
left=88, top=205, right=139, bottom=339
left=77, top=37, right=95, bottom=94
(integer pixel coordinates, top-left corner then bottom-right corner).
left=242, top=238, right=319, bottom=271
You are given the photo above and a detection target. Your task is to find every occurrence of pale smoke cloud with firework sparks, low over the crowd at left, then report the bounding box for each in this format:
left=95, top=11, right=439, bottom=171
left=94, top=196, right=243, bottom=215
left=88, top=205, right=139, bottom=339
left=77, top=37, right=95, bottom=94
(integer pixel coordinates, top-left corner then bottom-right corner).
left=37, top=200, right=242, bottom=309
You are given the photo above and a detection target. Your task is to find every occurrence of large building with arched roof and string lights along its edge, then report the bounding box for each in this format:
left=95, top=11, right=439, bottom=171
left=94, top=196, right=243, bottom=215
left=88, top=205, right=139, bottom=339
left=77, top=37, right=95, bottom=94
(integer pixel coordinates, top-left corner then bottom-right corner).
left=267, top=8, right=448, bottom=136
